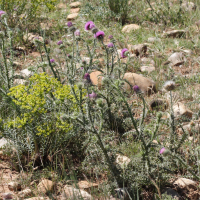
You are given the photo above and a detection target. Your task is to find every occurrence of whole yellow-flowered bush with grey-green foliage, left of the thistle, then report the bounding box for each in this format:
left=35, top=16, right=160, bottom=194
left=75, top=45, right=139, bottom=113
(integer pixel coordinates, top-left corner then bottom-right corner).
left=3, top=73, right=86, bottom=163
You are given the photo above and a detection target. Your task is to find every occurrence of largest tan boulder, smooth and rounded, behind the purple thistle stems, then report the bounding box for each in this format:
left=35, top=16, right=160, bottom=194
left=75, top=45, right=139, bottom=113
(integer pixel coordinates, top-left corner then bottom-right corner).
left=124, top=72, right=157, bottom=95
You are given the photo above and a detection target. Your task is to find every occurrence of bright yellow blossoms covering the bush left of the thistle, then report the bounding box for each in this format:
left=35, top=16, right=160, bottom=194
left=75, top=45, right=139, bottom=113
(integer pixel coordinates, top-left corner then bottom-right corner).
left=4, top=73, right=83, bottom=136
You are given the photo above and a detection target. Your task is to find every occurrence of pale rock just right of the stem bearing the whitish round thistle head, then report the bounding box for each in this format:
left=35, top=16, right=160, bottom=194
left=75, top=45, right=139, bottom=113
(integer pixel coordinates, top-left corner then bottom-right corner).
left=173, top=102, right=193, bottom=118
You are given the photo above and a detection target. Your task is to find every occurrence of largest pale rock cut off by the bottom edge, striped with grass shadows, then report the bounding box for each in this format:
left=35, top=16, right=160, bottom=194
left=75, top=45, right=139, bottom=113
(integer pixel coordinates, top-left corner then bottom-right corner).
left=62, top=185, right=93, bottom=200
